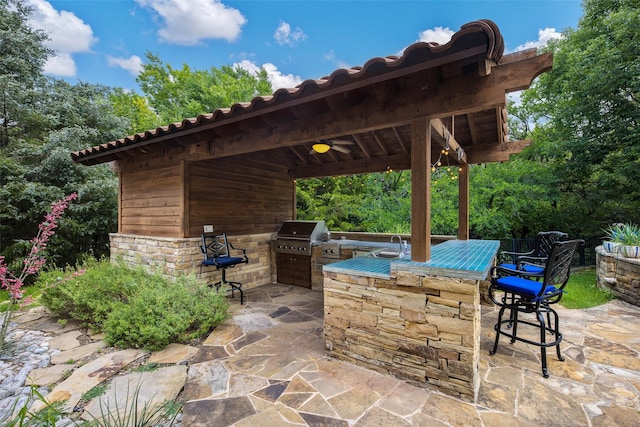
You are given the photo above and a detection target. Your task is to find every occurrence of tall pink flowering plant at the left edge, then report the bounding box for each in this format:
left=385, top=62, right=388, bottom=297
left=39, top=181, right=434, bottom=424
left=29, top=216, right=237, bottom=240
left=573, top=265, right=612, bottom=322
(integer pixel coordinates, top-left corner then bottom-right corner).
left=0, top=193, right=78, bottom=351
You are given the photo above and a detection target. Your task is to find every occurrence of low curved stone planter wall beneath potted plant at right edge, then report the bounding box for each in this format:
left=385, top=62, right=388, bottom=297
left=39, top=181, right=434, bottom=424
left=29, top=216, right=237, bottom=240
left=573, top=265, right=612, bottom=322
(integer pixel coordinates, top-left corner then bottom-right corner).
left=596, top=246, right=640, bottom=306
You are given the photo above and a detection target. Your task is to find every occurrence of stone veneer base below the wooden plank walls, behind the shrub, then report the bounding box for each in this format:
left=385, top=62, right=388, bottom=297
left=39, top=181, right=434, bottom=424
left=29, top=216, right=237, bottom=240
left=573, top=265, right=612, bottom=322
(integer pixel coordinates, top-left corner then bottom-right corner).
left=109, top=233, right=274, bottom=289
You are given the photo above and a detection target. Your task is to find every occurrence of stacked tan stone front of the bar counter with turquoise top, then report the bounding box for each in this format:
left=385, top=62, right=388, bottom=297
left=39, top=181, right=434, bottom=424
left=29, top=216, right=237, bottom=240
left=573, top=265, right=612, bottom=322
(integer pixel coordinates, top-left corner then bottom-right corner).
left=324, top=272, right=480, bottom=401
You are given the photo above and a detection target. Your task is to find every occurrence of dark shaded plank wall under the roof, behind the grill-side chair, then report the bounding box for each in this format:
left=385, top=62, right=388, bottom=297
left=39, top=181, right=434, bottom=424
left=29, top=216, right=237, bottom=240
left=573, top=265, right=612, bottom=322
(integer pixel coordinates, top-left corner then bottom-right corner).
left=188, top=158, right=295, bottom=237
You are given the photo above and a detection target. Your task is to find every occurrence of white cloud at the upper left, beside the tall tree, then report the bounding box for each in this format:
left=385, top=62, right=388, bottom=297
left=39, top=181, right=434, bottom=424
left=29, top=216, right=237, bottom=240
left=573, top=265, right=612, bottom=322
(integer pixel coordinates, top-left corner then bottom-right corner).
left=28, top=0, right=98, bottom=77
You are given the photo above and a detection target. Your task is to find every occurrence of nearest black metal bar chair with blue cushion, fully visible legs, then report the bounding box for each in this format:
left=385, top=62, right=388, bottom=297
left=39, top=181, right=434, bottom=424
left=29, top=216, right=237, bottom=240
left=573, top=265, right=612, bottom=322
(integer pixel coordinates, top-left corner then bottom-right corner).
left=489, top=240, right=584, bottom=378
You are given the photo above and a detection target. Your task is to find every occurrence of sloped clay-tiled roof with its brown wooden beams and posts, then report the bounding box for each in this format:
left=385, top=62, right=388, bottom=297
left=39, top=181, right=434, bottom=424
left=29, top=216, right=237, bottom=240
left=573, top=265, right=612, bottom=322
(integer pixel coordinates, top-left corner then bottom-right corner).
left=72, top=20, right=552, bottom=262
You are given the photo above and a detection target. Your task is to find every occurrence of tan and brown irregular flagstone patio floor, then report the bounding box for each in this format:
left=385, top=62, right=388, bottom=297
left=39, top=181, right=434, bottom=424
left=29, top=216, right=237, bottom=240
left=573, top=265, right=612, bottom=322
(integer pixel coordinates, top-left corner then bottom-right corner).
left=13, top=285, right=640, bottom=427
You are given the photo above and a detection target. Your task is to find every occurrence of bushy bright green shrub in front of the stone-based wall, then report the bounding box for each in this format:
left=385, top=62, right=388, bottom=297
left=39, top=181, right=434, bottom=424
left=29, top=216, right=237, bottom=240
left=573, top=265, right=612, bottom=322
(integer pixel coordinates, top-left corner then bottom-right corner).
left=38, top=260, right=228, bottom=350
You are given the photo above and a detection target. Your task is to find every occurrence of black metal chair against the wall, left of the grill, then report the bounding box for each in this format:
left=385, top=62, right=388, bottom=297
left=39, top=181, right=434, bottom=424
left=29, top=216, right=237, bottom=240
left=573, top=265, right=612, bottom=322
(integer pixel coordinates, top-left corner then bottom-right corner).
left=200, top=233, right=249, bottom=304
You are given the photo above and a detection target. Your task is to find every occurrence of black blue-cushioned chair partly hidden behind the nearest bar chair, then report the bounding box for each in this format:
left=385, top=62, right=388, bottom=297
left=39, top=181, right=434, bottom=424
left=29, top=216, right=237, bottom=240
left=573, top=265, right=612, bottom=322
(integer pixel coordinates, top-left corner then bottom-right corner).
left=499, top=231, right=569, bottom=277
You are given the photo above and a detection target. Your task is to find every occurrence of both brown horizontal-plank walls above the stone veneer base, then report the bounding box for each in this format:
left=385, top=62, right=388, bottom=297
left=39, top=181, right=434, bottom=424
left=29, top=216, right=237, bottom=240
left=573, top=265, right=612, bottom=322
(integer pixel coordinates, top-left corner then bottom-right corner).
left=118, top=147, right=295, bottom=237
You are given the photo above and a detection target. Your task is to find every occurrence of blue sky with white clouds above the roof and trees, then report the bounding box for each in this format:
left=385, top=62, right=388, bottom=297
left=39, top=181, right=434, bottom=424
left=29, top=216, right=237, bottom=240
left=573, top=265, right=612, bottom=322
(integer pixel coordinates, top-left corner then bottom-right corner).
left=25, top=0, right=582, bottom=91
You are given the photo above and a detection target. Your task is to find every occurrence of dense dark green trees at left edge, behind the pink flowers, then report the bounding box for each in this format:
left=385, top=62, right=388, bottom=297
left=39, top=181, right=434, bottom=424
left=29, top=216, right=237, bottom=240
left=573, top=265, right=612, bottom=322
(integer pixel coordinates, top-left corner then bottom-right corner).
left=0, top=0, right=124, bottom=268
